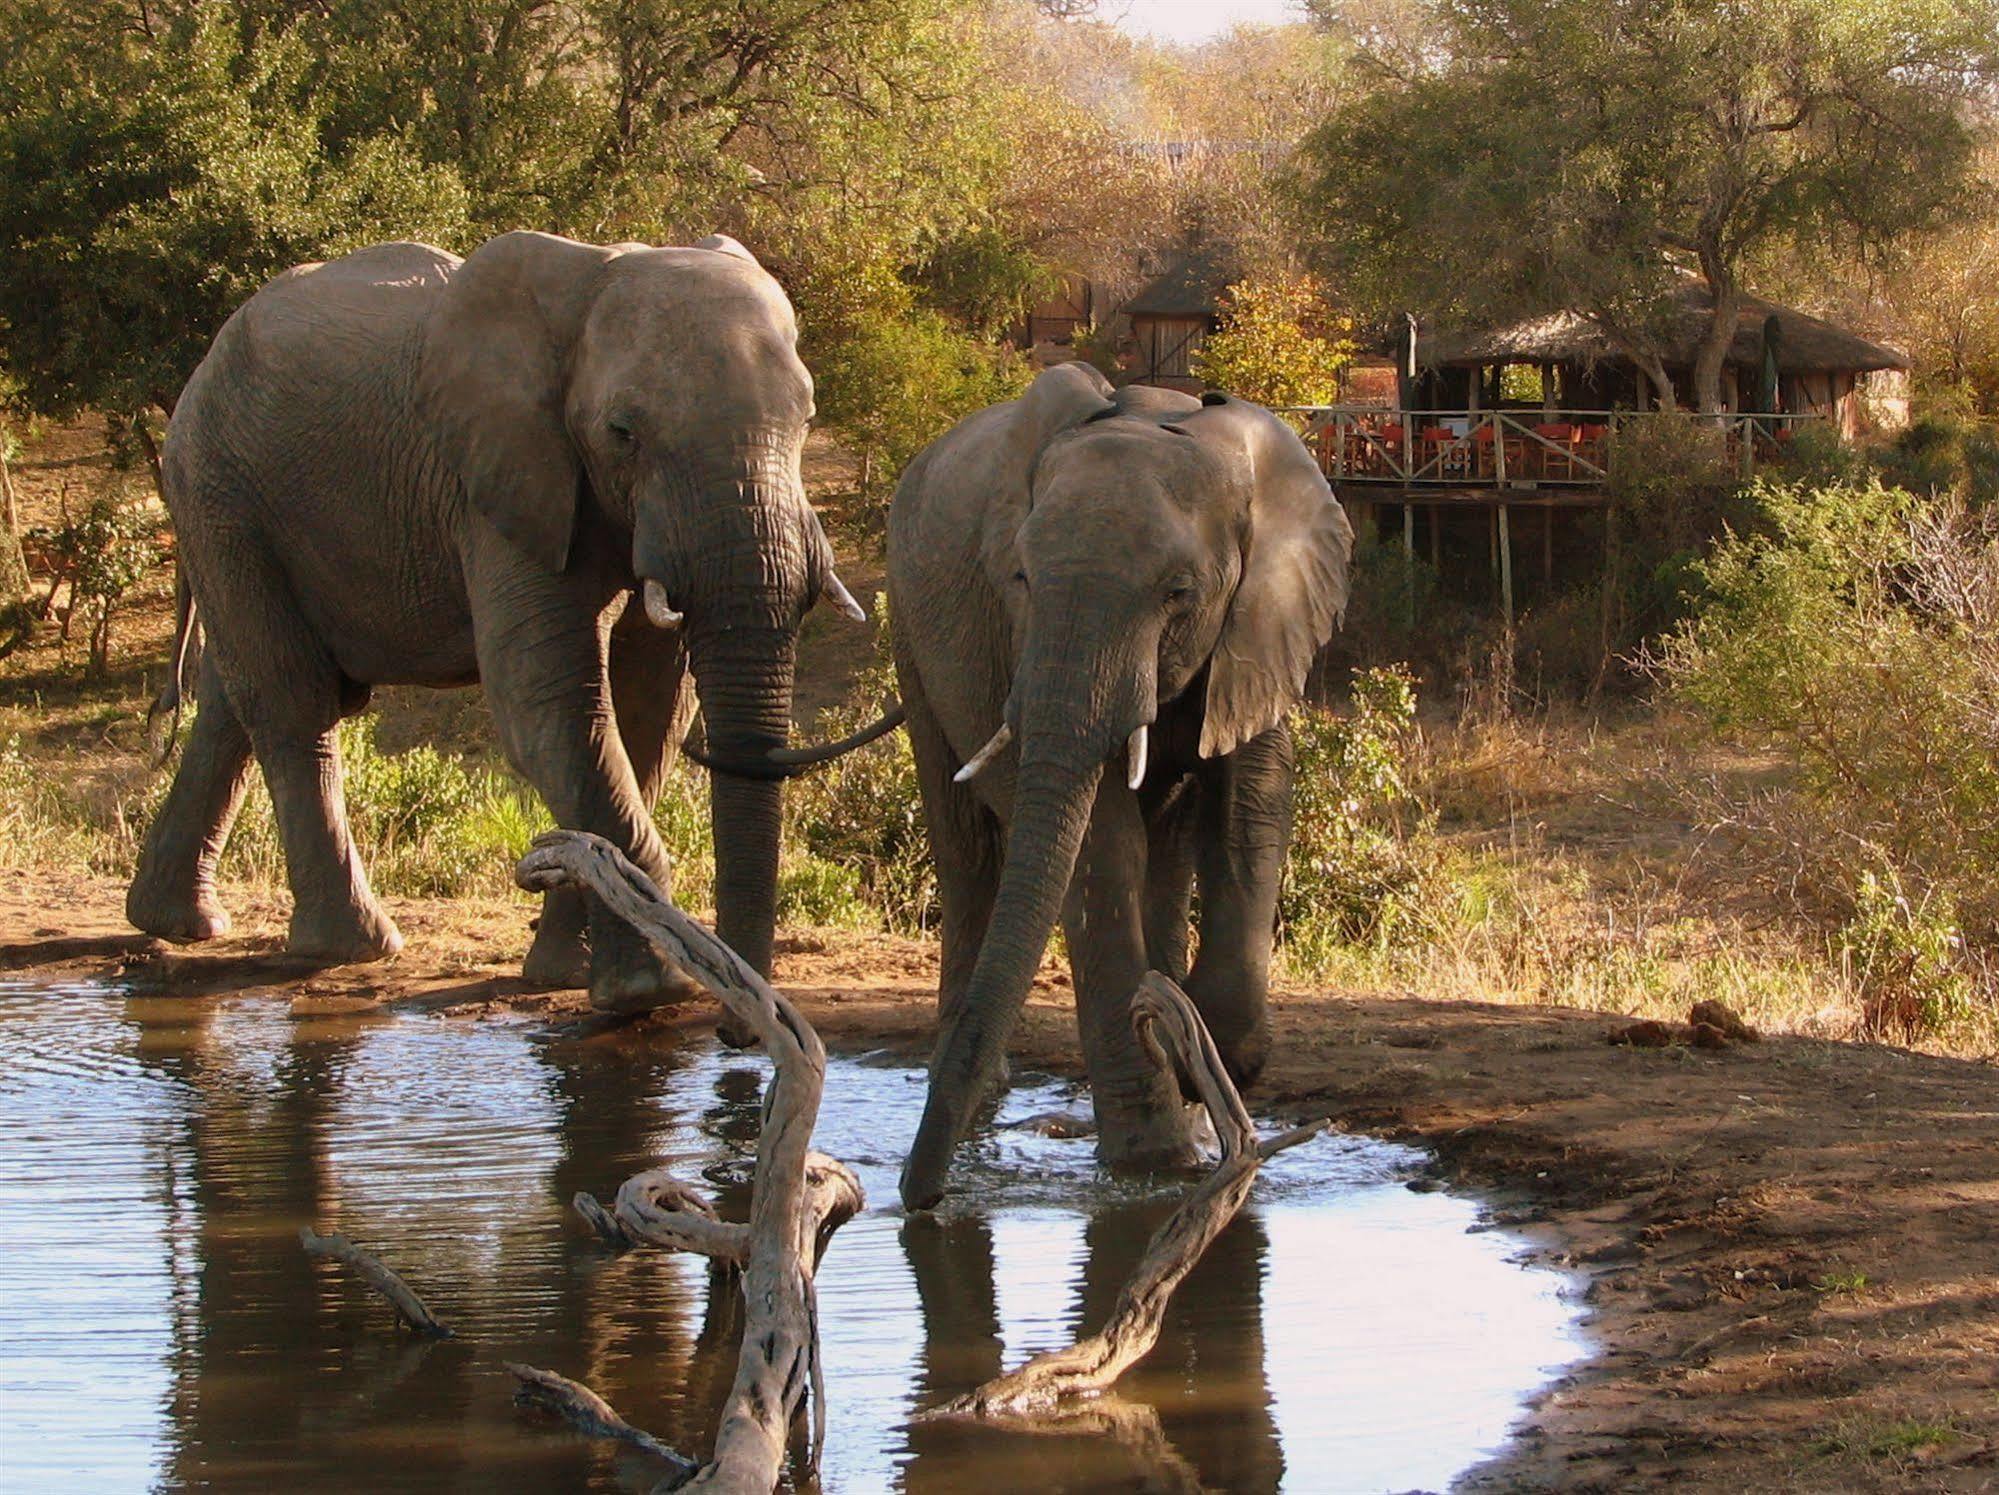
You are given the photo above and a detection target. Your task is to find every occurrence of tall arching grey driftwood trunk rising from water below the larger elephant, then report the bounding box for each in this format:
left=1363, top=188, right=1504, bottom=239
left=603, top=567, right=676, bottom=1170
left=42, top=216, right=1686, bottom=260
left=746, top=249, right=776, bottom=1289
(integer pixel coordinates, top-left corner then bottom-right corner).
left=514, top=831, right=858, bottom=1495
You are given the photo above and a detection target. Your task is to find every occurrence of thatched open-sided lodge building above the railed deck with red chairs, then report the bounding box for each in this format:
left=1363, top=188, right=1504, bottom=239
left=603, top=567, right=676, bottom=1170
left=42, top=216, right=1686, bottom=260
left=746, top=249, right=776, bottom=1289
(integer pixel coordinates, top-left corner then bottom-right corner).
left=1405, top=276, right=1909, bottom=436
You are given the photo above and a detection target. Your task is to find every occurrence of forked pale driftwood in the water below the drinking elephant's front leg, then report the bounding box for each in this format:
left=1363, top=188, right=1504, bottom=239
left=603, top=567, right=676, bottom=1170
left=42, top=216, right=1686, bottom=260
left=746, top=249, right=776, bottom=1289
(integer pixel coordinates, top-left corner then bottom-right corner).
left=928, top=971, right=1327, bottom=1417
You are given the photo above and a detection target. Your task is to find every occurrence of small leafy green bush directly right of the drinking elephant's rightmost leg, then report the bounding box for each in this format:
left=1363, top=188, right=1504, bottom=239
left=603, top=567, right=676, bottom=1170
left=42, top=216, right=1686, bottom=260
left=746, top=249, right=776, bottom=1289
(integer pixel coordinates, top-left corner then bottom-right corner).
left=1277, top=668, right=1459, bottom=969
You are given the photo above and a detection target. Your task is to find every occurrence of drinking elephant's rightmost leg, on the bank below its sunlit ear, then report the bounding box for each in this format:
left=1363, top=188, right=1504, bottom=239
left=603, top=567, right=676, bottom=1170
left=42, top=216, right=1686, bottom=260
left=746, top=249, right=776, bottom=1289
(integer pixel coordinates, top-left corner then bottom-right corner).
left=1187, top=724, right=1291, bottom=1087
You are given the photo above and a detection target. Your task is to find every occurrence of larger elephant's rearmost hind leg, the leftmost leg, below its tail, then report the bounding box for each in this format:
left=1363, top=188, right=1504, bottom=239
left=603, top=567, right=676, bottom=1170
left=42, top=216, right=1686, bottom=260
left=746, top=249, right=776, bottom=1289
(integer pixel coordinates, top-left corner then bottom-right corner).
left=126, top=660, right=250, bottom=939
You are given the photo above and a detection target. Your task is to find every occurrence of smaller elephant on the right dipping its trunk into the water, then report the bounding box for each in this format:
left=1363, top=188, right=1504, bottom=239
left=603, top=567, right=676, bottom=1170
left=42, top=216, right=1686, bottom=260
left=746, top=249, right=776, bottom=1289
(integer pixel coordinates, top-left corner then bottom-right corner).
left=888, top=364, right=1353, bottom=1209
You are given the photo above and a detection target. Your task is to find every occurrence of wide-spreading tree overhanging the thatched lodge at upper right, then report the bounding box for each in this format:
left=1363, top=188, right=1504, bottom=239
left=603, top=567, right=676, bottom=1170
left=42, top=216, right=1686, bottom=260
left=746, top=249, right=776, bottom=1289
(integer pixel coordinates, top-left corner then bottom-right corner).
left=1293, top=0, right=1999, bottom=410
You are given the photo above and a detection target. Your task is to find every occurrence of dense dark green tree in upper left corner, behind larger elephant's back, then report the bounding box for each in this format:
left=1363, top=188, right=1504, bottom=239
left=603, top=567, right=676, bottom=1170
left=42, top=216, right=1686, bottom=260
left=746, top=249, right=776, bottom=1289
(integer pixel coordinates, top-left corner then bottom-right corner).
left=0, top=0, right=464, bottom=425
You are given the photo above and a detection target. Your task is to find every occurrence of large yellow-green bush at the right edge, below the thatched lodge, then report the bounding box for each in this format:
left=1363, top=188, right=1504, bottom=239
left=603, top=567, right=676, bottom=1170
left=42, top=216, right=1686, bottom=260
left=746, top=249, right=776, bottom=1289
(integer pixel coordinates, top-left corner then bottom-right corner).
left=1655, top=482, right=1999, bottom=1033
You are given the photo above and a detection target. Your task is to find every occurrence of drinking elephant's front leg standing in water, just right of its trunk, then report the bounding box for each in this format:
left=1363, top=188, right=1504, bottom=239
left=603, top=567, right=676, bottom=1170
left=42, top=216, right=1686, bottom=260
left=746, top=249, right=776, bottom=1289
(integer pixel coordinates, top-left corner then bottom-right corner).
left=1061, top=773, right=1199, bottom=1167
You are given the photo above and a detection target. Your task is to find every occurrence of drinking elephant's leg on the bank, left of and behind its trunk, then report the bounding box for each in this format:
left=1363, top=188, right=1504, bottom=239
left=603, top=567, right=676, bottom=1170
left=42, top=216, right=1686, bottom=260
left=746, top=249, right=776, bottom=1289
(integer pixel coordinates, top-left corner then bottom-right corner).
left=902, top=672, right=1003, bottom=1031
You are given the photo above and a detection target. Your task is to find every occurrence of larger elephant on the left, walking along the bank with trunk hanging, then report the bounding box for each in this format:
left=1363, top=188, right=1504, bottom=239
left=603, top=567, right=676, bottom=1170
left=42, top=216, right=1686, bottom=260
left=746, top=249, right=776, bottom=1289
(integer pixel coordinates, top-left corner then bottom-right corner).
left=126, top=232, right=860, bottom=1009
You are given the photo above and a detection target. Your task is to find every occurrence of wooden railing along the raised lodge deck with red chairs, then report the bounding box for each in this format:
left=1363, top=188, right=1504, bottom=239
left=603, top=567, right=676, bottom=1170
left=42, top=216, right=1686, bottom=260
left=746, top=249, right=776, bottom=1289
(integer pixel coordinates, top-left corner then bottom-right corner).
left=1277, top=406, right=1821, bottom=488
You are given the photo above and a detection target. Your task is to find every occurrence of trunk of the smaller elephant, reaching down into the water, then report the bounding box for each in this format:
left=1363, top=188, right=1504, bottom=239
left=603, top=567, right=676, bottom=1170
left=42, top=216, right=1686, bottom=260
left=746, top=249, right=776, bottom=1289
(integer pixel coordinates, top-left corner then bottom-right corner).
left=902, top=608, right=1151, bottom=1209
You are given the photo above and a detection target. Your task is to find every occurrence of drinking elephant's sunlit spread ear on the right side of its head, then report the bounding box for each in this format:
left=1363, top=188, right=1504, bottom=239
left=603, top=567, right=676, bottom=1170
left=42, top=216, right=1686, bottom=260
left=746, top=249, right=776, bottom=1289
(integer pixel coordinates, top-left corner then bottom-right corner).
left=1179, top=394, right=1353, bottom=757
